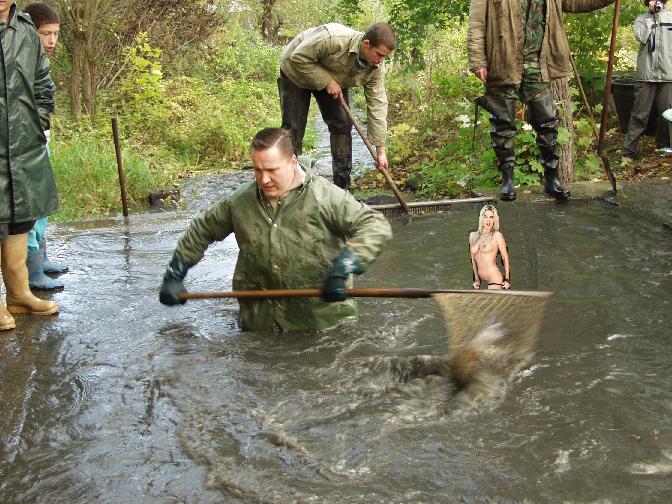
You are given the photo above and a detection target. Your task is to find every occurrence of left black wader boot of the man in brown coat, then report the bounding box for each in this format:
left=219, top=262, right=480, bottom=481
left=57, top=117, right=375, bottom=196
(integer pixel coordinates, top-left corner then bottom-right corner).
left=476, top=95, right=517, bottom=201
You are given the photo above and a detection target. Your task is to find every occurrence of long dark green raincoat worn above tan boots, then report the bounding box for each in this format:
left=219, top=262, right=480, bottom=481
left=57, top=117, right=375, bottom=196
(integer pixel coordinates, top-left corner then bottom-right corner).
left=0, top=5, right=58, bottom=223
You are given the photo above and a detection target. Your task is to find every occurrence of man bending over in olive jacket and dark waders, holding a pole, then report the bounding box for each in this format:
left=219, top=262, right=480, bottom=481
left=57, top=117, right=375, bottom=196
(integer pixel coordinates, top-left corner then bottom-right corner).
left=278, top=23, right=397, bottom=190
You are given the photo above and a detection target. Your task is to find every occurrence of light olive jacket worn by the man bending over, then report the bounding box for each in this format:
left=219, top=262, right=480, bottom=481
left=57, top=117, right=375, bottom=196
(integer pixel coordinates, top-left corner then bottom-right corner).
left=280, top=23, right=387, bottom=146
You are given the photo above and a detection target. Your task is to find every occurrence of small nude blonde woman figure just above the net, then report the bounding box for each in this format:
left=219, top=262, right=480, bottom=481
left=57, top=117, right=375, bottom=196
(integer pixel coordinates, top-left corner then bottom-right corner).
left=469, top=205, right=511, bottom=289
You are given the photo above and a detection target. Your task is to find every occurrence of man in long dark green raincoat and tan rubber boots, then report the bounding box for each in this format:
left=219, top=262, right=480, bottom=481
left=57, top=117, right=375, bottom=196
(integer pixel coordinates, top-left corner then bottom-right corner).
left=0, top=0, right=58, bottom=330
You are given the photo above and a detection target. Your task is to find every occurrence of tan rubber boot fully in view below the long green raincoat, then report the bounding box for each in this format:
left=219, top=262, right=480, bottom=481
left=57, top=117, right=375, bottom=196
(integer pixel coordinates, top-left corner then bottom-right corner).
left=0, top=233, right=58, bottom=315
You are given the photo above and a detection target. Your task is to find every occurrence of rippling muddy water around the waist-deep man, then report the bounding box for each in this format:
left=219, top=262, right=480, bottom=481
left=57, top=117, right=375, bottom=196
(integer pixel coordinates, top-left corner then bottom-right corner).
left=0, top=178, right=672, bottom=503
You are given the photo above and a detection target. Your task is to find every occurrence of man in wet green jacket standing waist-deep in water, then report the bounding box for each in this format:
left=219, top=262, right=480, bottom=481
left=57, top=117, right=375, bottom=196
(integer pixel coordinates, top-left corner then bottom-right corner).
left=159, top=128, right=392, bottom=331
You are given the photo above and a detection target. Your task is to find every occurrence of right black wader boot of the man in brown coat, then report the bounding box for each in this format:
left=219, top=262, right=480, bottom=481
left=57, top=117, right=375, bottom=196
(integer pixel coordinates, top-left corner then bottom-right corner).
left=527, top=95, right=570, bottom=200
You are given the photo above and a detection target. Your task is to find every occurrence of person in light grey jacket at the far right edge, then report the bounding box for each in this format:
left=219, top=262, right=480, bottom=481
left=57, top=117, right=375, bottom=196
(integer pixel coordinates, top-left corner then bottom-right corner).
left=621, top=0, right=672, bottom=165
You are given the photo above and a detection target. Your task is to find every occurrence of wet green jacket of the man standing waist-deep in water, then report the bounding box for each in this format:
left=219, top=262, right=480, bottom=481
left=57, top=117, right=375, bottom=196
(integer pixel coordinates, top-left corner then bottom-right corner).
left=175, top=163, right=392, bottom=331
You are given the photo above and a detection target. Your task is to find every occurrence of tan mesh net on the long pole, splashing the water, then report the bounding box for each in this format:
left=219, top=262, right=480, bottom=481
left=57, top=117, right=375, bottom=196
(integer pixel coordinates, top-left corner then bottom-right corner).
left=432, top=290, right=551, bottom=385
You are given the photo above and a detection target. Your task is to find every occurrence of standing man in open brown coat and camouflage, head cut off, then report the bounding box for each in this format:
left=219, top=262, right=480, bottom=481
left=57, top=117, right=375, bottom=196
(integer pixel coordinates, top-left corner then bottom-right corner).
left=467, top=0, right=614, bottom=200
